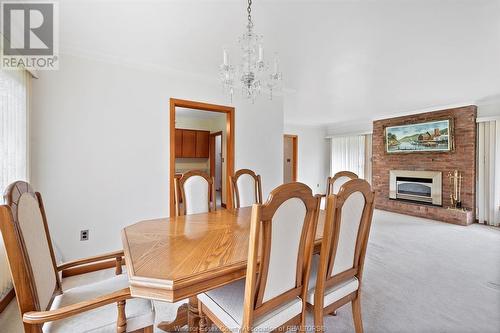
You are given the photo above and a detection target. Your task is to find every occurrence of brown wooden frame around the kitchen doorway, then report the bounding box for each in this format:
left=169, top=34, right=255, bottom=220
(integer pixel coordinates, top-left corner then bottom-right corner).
left=169, top=98, right=234, bottom=217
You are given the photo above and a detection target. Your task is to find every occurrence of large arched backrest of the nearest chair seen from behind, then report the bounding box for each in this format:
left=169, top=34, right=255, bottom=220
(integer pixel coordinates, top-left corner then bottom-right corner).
left=243, top=183, right=320, bottom=328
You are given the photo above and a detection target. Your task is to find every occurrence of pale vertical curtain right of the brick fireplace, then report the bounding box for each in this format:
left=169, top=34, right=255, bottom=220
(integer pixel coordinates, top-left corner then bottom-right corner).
left=476, top=120, right=500, bottom=226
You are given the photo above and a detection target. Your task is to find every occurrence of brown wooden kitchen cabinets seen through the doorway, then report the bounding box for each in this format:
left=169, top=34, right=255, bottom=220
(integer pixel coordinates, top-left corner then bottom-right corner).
left=175, top=128, right=210, bottom=158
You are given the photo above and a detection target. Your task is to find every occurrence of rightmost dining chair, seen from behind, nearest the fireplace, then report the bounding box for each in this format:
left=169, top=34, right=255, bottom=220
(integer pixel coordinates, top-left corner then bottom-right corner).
left=307, top=179, right=375, bottom=333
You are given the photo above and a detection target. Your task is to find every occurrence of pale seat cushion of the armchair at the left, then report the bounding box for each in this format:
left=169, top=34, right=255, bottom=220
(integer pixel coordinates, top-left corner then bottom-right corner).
left=43, top=274, right=155, bottom=333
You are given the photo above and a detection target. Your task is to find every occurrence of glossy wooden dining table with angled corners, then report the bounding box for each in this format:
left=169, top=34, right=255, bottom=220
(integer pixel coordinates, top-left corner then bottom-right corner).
left=122, top=207, right=325, bottom=331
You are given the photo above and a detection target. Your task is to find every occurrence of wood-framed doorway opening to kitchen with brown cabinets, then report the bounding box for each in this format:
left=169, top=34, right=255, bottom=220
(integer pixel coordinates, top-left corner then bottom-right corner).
left=169, top=98, right=234, bottom=216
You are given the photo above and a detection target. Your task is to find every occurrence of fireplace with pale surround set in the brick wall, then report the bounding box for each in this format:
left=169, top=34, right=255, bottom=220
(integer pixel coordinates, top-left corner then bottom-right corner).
left=389, top=170, right=442, bottom=206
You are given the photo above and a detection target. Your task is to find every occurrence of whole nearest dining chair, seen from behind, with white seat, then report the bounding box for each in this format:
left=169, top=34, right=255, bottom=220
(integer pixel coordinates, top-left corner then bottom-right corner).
left=198, top=183, right=319, bottom=332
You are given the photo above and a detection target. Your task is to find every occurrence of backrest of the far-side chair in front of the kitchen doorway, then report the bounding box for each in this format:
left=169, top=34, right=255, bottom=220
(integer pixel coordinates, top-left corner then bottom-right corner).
left=174, top=171, right=216, bottom=215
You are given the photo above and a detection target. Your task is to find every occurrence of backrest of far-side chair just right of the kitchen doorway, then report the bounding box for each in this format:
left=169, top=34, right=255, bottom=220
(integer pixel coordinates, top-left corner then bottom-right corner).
left=230, top=169, right=262, bottom=208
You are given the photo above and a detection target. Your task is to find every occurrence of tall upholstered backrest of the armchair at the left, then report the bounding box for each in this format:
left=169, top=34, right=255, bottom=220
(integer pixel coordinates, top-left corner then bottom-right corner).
left=0, top=181, right=61, bottom=326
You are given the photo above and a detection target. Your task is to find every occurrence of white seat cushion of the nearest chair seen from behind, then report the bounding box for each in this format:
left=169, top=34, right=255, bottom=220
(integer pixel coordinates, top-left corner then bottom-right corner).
left=198, top=279, right=302, bottom=332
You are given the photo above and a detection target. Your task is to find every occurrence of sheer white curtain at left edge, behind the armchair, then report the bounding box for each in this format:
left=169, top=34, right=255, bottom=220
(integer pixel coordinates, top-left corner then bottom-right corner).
left=0, top=70, right=29, bottom=299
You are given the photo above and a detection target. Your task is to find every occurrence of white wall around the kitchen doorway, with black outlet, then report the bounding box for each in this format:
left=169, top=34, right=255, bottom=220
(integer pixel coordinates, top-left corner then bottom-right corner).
left=31, top=55, right=283, bottom=260
